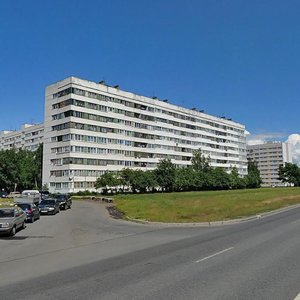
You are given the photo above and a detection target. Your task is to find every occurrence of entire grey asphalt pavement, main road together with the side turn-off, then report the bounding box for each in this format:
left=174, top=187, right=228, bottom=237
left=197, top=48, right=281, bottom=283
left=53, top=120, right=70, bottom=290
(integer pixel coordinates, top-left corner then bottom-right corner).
left=0, top=202, right=300, bottom=300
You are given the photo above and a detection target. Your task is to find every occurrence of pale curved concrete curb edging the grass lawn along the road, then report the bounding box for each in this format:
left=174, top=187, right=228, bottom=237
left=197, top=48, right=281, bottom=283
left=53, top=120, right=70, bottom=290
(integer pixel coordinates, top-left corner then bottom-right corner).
left=126, top=204, right=300, bottom=227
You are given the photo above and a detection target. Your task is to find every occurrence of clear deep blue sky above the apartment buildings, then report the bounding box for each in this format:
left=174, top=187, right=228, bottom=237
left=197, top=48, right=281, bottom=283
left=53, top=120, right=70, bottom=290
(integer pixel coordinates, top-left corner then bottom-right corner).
left=0, top=0, right=300, bottom=140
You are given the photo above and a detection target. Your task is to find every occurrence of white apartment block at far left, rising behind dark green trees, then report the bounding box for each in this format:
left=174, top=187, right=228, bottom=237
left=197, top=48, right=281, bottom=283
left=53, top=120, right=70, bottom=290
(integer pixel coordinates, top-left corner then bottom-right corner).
left=0, top=124, right=44, bottom=151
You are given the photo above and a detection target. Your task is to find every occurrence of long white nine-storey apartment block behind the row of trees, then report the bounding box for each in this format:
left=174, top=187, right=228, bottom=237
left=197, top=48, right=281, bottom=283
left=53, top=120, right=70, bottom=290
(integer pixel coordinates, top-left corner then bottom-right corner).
left=43, top=77, right=247, bottom=192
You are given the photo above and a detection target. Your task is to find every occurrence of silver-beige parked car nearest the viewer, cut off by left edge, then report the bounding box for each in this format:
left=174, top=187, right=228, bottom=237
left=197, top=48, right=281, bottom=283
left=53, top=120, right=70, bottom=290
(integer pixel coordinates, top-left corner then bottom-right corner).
left=0, top=206, right=26, bottom=236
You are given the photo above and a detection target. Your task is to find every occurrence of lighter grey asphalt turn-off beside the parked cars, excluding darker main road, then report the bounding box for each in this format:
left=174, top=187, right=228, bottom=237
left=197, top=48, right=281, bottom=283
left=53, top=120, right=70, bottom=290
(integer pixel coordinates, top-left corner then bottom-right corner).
left=0, top=201, right=199, bottom=287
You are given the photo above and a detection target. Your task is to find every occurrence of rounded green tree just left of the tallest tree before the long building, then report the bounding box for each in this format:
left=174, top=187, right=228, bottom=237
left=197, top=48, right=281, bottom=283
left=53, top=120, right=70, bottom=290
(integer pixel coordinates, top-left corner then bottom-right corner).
left=154, top=158, right=176, bottom=192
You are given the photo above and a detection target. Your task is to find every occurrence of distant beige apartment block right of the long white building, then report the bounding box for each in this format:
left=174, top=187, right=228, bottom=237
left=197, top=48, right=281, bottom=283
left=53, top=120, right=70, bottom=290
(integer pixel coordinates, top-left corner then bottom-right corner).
left=247, top=142, right=292, bottom=186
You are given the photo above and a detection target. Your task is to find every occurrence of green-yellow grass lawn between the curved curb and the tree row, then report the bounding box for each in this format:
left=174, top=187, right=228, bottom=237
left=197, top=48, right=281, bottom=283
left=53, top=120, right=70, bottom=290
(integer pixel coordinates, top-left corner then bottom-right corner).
left=114, top=188, right=300, bottom=223
